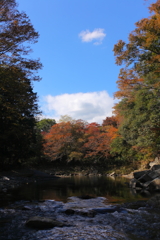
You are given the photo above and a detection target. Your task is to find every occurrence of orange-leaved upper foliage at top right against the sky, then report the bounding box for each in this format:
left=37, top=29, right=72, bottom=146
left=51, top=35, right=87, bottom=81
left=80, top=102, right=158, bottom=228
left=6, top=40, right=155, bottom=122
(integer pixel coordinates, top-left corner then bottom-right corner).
left=114, top=0, right=160, bottom=79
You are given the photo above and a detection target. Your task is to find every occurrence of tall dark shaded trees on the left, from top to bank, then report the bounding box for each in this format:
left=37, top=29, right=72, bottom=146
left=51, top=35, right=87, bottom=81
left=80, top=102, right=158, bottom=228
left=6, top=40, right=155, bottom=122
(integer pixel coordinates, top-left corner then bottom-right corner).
left=0, top=0, right=41, bottom=166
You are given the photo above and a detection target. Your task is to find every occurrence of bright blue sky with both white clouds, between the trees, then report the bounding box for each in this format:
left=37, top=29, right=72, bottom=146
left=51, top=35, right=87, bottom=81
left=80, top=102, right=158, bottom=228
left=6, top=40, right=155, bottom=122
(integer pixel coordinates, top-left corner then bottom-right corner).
left=17, top=0, right=155, bottom=123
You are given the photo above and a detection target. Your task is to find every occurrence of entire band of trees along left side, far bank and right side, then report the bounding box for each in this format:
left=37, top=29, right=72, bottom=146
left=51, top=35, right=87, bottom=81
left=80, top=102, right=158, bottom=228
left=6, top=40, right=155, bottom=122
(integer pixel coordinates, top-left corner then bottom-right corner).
left=0, top=0, right=160, bottom=170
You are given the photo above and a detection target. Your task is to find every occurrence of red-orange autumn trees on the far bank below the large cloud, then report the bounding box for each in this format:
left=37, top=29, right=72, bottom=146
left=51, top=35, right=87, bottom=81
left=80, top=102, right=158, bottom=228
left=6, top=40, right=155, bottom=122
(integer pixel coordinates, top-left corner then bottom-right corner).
left=42, top=117, right=117, bottom=164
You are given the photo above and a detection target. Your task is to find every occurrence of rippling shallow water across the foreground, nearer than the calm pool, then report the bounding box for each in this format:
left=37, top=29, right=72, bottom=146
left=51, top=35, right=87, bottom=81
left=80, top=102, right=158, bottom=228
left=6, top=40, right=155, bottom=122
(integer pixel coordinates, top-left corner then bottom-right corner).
left=0, top=196, right=160, bottom=240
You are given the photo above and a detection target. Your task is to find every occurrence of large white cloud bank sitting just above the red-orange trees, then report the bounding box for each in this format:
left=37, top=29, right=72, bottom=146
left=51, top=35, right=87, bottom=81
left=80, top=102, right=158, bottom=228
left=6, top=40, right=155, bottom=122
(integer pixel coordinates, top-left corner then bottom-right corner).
left=42, top=91, right=115, bottom=124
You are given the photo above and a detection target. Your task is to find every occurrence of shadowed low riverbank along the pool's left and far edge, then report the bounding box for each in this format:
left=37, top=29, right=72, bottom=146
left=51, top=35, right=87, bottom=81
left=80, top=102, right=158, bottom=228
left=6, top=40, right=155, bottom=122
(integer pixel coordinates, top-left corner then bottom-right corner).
left=0, top=167, right=117, bottom=197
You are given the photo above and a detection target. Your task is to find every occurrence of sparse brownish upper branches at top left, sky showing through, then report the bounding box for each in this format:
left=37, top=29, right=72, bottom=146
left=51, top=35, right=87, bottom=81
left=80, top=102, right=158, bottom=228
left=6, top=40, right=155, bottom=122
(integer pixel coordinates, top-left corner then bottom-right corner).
left=0, top=0, right=41, bottom=74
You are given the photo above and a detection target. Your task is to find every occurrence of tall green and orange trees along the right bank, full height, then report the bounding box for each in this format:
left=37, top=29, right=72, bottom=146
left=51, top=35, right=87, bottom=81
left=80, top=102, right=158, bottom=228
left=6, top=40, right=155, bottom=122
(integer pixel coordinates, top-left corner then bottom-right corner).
left=112, top=0, right=160, bottom=163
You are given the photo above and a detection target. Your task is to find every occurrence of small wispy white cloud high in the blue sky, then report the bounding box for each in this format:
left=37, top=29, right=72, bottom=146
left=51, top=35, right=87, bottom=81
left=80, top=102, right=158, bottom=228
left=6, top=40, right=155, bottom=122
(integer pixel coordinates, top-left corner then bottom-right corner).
left=79, top=28, right=106, bottom=45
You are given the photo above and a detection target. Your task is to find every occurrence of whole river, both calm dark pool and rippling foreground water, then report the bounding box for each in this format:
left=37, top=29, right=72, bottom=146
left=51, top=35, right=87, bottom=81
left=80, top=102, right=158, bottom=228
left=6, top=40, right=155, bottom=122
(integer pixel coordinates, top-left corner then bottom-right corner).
left=0, top=176, right=160, bottom=240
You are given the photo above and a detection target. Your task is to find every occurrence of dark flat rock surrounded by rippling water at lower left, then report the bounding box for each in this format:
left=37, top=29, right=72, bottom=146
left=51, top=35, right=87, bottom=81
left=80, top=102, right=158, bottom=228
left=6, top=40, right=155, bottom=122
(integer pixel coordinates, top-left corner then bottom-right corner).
left=26, top=216, right=64, bottom=229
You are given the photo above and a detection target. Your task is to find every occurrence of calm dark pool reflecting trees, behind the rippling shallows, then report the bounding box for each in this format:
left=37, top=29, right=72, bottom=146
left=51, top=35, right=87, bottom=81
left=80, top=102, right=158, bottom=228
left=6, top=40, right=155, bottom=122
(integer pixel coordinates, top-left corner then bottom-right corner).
left=14, top=176, right=148, bottom=204
